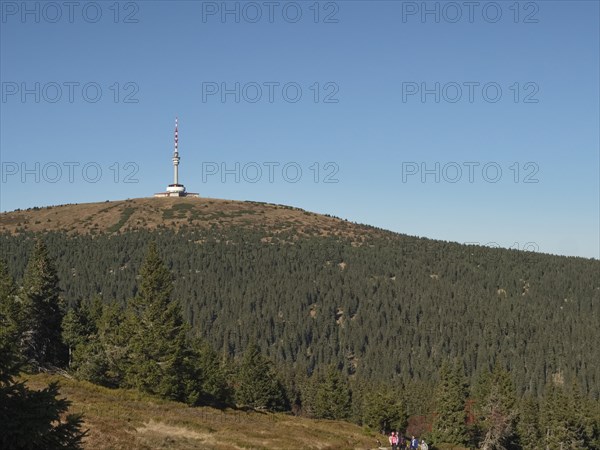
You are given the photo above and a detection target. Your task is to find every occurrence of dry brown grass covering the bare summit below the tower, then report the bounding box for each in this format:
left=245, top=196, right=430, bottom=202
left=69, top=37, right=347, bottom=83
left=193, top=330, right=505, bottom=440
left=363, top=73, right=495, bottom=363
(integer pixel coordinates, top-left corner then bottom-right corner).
left=0, top=197, right=386, bottom=243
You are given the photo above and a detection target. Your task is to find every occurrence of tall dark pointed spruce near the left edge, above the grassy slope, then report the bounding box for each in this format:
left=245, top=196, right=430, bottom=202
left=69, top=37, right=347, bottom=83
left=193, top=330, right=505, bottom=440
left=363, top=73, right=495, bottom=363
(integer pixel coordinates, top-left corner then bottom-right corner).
left=21, top=239, right=67, bottom=369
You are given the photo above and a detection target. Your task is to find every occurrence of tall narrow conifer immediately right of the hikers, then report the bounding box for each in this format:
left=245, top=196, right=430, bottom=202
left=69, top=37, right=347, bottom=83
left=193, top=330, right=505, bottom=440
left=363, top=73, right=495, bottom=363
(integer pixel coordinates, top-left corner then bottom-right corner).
left=431, top=361, right=467, bottom=445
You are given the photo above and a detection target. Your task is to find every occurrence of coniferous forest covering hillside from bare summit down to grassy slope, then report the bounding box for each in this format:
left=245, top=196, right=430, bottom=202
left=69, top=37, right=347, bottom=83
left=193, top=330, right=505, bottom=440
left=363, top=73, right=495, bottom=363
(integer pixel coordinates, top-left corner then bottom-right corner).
left=0, top=201, right=600, bottom=450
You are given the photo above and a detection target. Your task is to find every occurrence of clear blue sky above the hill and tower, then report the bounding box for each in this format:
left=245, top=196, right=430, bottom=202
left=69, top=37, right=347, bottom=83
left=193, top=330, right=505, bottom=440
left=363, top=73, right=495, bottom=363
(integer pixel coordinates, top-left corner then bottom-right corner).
left=0, top=0, right=600, bottom=258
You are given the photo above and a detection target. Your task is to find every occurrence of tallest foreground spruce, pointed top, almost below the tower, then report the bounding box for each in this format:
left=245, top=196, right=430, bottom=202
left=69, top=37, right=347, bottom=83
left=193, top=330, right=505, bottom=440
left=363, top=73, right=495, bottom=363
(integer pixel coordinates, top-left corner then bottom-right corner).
left=123, top=241, right=187, bottom=400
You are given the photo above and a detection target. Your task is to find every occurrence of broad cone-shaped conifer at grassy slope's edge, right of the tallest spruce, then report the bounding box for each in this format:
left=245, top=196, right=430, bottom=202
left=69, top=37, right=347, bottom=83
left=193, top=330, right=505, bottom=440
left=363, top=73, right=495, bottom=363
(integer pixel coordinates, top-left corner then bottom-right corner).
left=235, top=344, right=289, bottom=411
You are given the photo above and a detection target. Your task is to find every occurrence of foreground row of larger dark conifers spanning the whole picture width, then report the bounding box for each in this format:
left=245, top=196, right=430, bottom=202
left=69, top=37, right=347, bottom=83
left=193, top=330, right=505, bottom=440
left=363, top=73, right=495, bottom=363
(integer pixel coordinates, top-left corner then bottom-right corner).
left=0, top=240, right=600, bottom=450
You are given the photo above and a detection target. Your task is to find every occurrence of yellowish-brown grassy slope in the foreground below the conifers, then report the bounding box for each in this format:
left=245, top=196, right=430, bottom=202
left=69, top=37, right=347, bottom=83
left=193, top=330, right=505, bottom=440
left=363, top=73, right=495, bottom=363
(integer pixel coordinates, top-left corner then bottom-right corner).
left=24, top=374, right=385, bottom=450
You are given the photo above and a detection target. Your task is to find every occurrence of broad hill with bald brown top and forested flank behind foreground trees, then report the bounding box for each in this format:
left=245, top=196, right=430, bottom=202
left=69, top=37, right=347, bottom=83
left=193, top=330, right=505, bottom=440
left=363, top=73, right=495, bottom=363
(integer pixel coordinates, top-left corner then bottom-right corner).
left=0, top=198, right=600, bottom=400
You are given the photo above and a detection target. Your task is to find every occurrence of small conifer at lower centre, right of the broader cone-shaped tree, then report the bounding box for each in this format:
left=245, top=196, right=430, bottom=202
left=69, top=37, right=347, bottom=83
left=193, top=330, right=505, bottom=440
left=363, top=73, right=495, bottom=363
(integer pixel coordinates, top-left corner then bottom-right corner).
left=314, top=365, right=352, bottom=419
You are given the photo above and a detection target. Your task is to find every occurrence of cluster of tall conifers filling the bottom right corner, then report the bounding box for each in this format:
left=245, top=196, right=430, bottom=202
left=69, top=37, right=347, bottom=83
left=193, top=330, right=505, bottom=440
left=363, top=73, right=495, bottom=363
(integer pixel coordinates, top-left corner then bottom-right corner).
left=424, top=361, right=600, bottom=450
